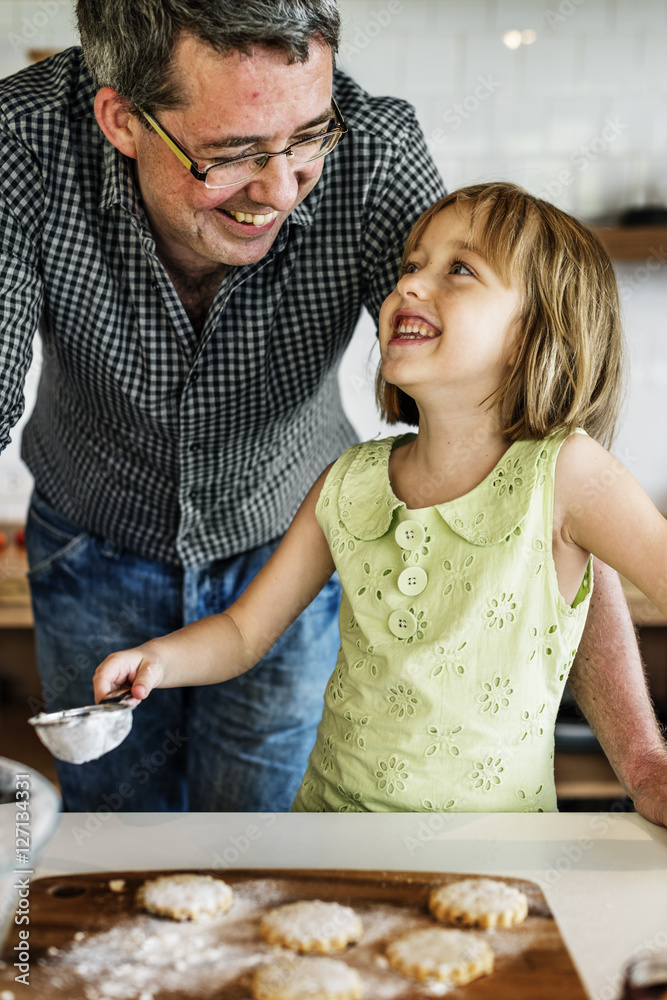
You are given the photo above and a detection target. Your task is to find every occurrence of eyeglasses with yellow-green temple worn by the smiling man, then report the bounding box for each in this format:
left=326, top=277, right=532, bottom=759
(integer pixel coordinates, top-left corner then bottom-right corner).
left=137, top=97, right=347, bottom=188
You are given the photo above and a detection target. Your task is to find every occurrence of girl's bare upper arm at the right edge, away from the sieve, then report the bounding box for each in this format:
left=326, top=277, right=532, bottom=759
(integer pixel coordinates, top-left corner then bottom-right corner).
left=554, top=434, right=667, bottom=615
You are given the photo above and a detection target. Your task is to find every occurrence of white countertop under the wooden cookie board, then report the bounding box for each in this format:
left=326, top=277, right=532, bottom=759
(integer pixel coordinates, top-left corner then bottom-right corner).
left=35, top=812, right=667, bottom=1000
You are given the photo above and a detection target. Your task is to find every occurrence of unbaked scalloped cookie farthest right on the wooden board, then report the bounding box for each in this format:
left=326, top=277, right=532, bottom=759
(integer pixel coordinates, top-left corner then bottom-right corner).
left=428, top=878, right=528, bottom=927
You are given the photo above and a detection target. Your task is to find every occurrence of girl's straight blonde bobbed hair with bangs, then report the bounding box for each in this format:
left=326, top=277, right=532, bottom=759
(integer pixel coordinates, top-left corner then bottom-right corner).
left=376, top=182, right=624, bottom=443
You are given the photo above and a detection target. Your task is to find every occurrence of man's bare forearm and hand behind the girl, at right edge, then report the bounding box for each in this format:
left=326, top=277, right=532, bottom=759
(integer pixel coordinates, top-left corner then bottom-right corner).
left=568, top=560, right=667, bottom=826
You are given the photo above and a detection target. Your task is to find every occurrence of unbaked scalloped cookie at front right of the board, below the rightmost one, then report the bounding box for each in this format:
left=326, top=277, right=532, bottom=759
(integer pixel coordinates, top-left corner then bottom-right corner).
left=387, top=927, right=493, bottom=986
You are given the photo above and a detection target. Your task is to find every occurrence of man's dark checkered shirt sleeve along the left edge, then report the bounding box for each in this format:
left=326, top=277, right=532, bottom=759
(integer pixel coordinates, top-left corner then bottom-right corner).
left=0, top=136, right=44, bottom=451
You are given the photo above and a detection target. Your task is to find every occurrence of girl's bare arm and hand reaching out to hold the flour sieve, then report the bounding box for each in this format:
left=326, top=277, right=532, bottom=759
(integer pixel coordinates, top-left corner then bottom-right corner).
left=93, top=468, right=335, bottom=701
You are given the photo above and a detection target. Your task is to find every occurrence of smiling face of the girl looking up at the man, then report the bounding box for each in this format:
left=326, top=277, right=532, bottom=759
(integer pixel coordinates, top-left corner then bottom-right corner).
left=380, top=205, right=522, bottom=405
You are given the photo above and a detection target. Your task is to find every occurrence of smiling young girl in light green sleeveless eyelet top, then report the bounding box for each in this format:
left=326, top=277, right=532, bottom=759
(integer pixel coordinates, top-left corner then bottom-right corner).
left=94, top=183, right=667, bottom=811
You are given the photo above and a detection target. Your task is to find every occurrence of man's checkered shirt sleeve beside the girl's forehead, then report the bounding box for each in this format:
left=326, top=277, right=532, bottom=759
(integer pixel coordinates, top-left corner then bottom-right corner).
left=362, top=102, right=446, bottom=323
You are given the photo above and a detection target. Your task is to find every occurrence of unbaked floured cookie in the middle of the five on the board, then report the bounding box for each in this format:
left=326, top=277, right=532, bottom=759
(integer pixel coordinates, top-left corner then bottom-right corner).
left=259, top=899, right=363, bottom=954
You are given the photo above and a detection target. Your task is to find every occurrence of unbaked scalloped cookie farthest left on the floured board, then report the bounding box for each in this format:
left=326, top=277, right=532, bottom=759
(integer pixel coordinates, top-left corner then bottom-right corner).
left=136, top=874, right=234, bottom=920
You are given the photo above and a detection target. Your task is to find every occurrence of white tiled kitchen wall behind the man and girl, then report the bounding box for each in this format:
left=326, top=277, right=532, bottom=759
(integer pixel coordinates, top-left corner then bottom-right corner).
left=0, top=0, right=667, bottom=519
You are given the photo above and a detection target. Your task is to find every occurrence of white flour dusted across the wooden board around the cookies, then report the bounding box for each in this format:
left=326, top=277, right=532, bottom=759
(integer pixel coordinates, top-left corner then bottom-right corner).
left=5, top=872, right=583, bottom=1000
